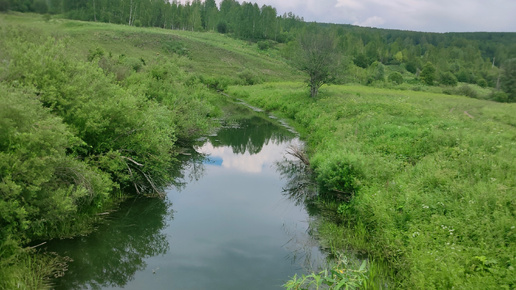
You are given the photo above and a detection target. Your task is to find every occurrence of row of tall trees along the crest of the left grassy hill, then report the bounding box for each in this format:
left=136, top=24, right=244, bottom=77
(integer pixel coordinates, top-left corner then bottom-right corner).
left=0, top=0, right=303, bottom=42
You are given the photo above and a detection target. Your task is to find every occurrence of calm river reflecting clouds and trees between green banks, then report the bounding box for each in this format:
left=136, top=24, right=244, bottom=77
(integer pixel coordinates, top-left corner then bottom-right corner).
left=47, top=108, right=324, bottom=290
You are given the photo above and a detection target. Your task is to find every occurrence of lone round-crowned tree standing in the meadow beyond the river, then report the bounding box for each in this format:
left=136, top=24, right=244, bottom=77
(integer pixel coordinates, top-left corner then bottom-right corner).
left=295, top=26, right=337, bottom=98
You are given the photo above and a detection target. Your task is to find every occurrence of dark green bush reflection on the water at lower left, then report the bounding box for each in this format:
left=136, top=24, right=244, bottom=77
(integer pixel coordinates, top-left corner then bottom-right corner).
left=48, top=198, right=172, bottom=289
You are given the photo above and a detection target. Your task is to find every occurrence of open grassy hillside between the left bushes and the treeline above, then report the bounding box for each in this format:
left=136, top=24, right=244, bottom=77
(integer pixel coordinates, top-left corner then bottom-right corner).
left=0, top=13, right=302, bottom=83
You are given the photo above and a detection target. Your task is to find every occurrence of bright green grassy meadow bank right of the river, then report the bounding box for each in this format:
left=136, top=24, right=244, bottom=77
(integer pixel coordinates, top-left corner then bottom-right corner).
left=229, top=83, right=516, bottom=289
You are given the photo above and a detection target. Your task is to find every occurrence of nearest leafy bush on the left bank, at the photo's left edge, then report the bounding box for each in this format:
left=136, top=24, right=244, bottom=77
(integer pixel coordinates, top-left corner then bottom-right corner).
left=0, top=86, right=113, bottom=249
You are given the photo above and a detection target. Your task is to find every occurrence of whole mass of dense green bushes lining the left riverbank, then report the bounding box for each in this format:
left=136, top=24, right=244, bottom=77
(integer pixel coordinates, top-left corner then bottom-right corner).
left=0, top=27, right=215, bottom=289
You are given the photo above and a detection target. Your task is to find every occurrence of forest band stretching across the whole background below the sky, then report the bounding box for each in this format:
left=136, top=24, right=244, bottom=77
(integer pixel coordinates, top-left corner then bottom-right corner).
left=0, top=0, right=516, bottom=102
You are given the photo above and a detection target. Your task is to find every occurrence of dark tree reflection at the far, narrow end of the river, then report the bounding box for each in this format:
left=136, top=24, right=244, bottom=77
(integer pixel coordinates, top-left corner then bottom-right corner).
left=210, top=116, right=294, bottom=154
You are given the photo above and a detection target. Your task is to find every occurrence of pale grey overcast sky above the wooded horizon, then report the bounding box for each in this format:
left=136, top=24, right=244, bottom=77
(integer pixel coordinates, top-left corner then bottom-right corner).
left=213, top=0, right=516, bottom=32
